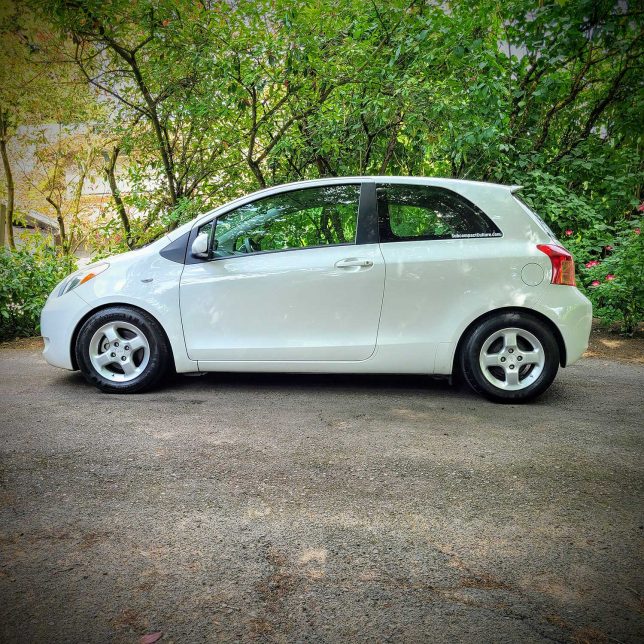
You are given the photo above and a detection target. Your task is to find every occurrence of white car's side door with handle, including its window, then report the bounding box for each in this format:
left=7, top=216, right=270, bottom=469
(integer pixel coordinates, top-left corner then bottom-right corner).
left=180, top=183, right=385, bottom=361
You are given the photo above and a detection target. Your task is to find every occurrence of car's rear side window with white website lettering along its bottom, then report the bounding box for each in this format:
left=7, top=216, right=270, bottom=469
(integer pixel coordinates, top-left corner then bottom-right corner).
left=377, top=184, right=501, bottom=242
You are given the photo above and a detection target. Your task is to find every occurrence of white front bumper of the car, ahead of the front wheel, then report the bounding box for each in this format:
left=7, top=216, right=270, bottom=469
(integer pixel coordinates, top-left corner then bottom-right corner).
left=40, top=291, right=90, bottom=370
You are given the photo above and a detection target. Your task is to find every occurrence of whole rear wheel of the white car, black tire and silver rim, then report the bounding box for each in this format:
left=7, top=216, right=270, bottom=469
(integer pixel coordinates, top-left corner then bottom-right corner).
left=459, top=313, right=559, bottom=403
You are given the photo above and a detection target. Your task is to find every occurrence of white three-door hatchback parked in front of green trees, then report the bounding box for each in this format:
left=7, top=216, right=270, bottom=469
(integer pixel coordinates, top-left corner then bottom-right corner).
left=41, top=177, right=592, bottom=402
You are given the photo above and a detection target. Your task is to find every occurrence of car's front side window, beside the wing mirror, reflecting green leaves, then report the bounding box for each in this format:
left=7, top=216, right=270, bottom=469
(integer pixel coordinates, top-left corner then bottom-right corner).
left=209, top=184, right=360, bottom=257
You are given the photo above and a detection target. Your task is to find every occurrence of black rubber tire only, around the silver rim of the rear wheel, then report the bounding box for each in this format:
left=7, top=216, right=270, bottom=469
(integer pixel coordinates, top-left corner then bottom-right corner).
left=460, top=313, right=559, bottom=403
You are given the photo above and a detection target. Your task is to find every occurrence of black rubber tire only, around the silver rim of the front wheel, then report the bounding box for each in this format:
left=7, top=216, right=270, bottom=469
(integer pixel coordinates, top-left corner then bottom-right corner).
left=75, top=307, right=168, bottom=393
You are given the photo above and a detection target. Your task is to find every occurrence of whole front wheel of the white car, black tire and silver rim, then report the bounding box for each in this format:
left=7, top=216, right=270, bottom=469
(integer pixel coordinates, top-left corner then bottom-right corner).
left=74, top=306, right=172, bottom=394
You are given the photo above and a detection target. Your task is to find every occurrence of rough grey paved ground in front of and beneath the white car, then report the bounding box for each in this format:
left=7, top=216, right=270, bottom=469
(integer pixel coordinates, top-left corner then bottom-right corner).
left=0, top=348, right=644, bottom=643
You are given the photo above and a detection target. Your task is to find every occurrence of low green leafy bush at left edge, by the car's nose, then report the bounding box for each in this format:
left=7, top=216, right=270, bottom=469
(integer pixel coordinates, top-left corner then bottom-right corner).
left=0, top=237, right=76, bottom=340
